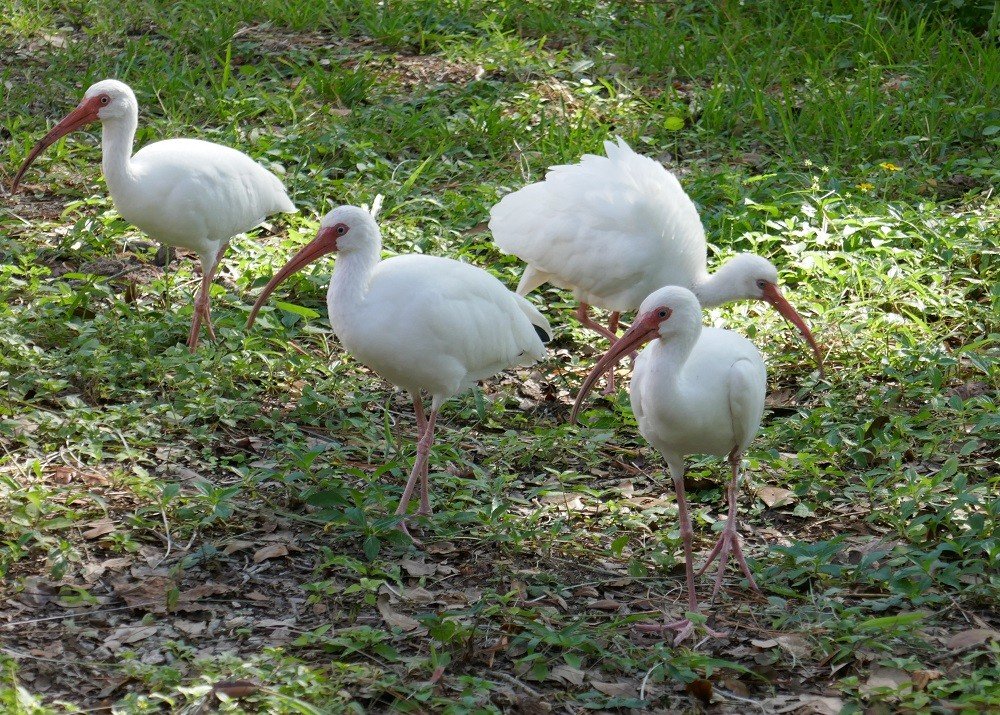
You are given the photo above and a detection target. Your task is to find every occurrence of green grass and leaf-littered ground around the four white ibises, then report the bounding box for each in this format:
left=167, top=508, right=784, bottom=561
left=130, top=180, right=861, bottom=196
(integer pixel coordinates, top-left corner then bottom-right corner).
left=0, top=0, right=1000, bottom=713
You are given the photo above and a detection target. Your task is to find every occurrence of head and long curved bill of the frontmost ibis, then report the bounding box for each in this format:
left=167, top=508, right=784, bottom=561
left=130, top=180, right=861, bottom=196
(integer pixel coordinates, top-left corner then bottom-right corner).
left=569, top=286, right=701, bottom=423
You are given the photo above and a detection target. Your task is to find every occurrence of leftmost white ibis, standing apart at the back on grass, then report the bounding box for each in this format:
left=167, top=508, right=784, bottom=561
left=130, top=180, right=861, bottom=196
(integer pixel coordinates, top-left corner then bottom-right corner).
left=11, top=79, right=296, bottom=352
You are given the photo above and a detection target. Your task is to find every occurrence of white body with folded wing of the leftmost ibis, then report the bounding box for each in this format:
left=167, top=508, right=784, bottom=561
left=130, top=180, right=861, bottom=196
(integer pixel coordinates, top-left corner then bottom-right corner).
left=123, top=139, right=296, bottom=245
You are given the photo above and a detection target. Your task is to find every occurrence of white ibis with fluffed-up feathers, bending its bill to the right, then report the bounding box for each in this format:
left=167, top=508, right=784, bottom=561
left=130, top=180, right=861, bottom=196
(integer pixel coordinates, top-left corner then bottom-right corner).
left=490, top=138, right=823, bottom=390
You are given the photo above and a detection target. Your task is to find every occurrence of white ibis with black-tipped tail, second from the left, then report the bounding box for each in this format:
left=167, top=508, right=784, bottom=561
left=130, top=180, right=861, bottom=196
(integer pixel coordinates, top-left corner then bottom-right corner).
left=247, top=206, right=550, bottom=532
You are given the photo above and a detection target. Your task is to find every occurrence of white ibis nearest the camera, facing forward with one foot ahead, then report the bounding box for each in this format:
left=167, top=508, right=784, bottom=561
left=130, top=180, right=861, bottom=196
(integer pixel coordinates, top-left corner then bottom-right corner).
left=570, top=286, right=767, bottom=643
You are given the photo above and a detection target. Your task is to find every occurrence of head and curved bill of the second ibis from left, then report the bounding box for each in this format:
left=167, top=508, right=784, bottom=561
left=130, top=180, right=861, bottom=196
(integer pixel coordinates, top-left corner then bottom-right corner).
left=247, top=206, right=380, bottom=330
